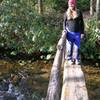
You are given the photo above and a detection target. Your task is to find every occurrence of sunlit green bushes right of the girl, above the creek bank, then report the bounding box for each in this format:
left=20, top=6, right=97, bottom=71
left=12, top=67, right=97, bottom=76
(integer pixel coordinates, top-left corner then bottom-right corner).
left=81, top=19, right=100, bottom=59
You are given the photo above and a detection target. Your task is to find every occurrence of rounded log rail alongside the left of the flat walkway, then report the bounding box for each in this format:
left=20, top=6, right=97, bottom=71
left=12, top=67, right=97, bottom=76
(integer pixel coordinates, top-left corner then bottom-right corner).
left=46, top=32, right=66, bottom=100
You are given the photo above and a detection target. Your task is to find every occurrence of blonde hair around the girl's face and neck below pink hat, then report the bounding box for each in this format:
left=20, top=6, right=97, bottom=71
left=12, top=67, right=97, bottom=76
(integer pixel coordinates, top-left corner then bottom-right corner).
left=66, top=8, right=78, bottom=20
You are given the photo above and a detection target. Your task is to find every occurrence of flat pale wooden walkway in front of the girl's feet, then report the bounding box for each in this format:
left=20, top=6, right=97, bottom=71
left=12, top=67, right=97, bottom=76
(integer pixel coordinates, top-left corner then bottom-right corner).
left=61, top=62, right=89, bottom=100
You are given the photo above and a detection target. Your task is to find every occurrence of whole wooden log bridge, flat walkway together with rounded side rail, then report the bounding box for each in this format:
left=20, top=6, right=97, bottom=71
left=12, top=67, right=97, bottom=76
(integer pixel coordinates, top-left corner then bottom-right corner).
left=46, top=32, right=89, bottom=100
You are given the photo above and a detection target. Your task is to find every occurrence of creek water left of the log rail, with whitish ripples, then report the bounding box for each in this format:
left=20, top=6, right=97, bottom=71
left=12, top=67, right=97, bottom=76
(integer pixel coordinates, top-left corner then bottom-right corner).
left=0, top=60, right=52, bottom=100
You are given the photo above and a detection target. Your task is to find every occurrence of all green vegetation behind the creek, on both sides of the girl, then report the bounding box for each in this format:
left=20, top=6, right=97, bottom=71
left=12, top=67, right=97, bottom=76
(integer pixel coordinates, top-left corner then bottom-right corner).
left=0, top=0, right=100, bottom=59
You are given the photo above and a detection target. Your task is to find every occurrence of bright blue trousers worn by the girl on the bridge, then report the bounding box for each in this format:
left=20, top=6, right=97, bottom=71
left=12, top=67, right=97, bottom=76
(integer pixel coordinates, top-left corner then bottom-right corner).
left=66, top=32, right=81, bottom=60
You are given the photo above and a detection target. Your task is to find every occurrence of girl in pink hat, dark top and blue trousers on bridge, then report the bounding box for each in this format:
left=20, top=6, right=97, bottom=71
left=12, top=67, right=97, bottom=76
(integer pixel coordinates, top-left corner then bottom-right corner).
left=63, top=0, right=84, bottom=64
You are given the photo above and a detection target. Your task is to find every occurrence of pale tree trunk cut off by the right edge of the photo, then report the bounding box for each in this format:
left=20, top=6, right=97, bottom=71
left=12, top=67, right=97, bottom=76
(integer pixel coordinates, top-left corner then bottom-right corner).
left=96, top=0, right=100, bottom=29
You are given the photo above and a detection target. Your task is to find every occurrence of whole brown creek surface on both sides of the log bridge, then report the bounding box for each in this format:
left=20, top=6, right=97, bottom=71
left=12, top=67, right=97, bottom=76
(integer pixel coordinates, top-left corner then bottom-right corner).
left=0, top=60, right=100, bottom=100
